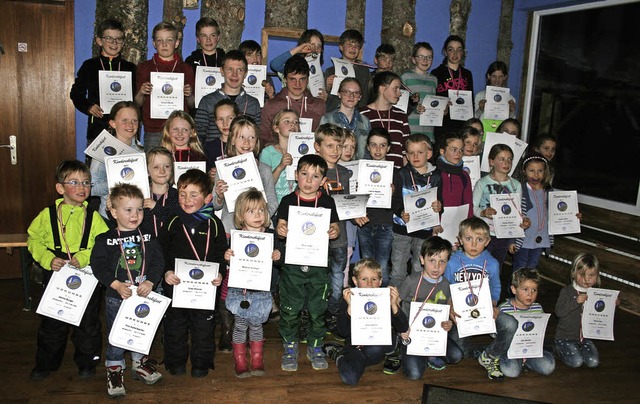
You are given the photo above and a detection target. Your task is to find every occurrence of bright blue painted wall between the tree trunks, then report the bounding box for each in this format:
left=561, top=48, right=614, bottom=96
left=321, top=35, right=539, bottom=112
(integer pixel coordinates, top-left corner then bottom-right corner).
left=75, top=0, right=587, bottom=160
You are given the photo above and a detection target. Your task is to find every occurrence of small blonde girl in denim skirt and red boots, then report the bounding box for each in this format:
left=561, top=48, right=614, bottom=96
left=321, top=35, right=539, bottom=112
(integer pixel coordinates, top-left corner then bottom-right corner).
left=224, top=188, right=284, bottom=378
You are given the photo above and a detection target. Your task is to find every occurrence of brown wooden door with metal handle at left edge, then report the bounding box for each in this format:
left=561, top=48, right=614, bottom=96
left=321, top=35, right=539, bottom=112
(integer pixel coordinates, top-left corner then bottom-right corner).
left=0, top=0, right=76, bottom=278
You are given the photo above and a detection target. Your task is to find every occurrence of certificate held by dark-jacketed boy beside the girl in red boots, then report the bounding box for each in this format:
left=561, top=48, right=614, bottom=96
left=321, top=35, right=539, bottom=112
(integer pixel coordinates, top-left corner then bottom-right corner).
left=172, top=258, right=220, bottom=310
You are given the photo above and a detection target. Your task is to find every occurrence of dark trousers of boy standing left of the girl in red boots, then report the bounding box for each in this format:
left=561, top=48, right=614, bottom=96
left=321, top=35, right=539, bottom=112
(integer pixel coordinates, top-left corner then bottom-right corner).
left=164, top=307, right=216, bottom=369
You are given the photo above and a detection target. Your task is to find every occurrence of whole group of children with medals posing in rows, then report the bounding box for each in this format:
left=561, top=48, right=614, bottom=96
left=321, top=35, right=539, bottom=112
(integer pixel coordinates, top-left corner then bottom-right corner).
left=29, top=18, right=612, bottom=397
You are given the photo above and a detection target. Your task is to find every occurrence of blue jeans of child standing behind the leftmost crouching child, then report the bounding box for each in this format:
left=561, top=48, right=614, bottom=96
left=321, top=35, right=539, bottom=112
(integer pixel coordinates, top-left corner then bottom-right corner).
left=358, top=223, right=393, bottom=286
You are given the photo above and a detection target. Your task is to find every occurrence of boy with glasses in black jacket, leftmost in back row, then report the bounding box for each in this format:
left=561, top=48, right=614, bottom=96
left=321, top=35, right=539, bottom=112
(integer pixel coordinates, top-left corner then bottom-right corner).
left=69, top=20, right=136, bottom=155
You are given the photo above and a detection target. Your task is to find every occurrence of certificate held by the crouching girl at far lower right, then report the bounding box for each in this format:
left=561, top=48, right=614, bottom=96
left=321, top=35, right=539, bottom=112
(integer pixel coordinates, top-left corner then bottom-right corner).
left=581, top=288, right=620, bottom=341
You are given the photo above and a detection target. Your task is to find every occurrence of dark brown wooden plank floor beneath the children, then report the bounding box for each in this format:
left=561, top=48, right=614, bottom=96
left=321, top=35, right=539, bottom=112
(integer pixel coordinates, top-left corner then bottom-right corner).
left=0, top=279, right=640, bottom=403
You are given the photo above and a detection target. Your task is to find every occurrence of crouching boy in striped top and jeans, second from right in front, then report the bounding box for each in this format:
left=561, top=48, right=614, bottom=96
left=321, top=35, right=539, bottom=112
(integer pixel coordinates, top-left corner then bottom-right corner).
left=498, top=268, right=556, bottom=377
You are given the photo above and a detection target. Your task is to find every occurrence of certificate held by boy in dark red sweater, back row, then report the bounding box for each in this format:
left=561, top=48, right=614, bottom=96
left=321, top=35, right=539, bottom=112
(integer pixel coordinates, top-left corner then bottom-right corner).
left=151, top=72, right=184, bottom=119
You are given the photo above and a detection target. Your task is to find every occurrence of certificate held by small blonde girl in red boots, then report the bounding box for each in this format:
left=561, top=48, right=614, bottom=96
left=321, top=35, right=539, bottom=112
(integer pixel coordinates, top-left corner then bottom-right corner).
left=229, top=230, right=273, bottom=292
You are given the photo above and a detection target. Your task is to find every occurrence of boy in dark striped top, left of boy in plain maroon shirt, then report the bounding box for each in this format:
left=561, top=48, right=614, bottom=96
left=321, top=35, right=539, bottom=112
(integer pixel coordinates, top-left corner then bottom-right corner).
left=194, top=49, right=260, bottom=144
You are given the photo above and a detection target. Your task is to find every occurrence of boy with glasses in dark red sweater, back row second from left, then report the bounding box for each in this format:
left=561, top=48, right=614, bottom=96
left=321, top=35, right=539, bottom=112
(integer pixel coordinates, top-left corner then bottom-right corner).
left=135, top=21, right=195, bottom=152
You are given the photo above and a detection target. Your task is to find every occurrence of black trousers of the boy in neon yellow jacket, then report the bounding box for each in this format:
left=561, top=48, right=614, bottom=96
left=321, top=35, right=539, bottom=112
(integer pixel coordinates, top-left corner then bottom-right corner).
left=36, top=270, right=102, bottom=371
